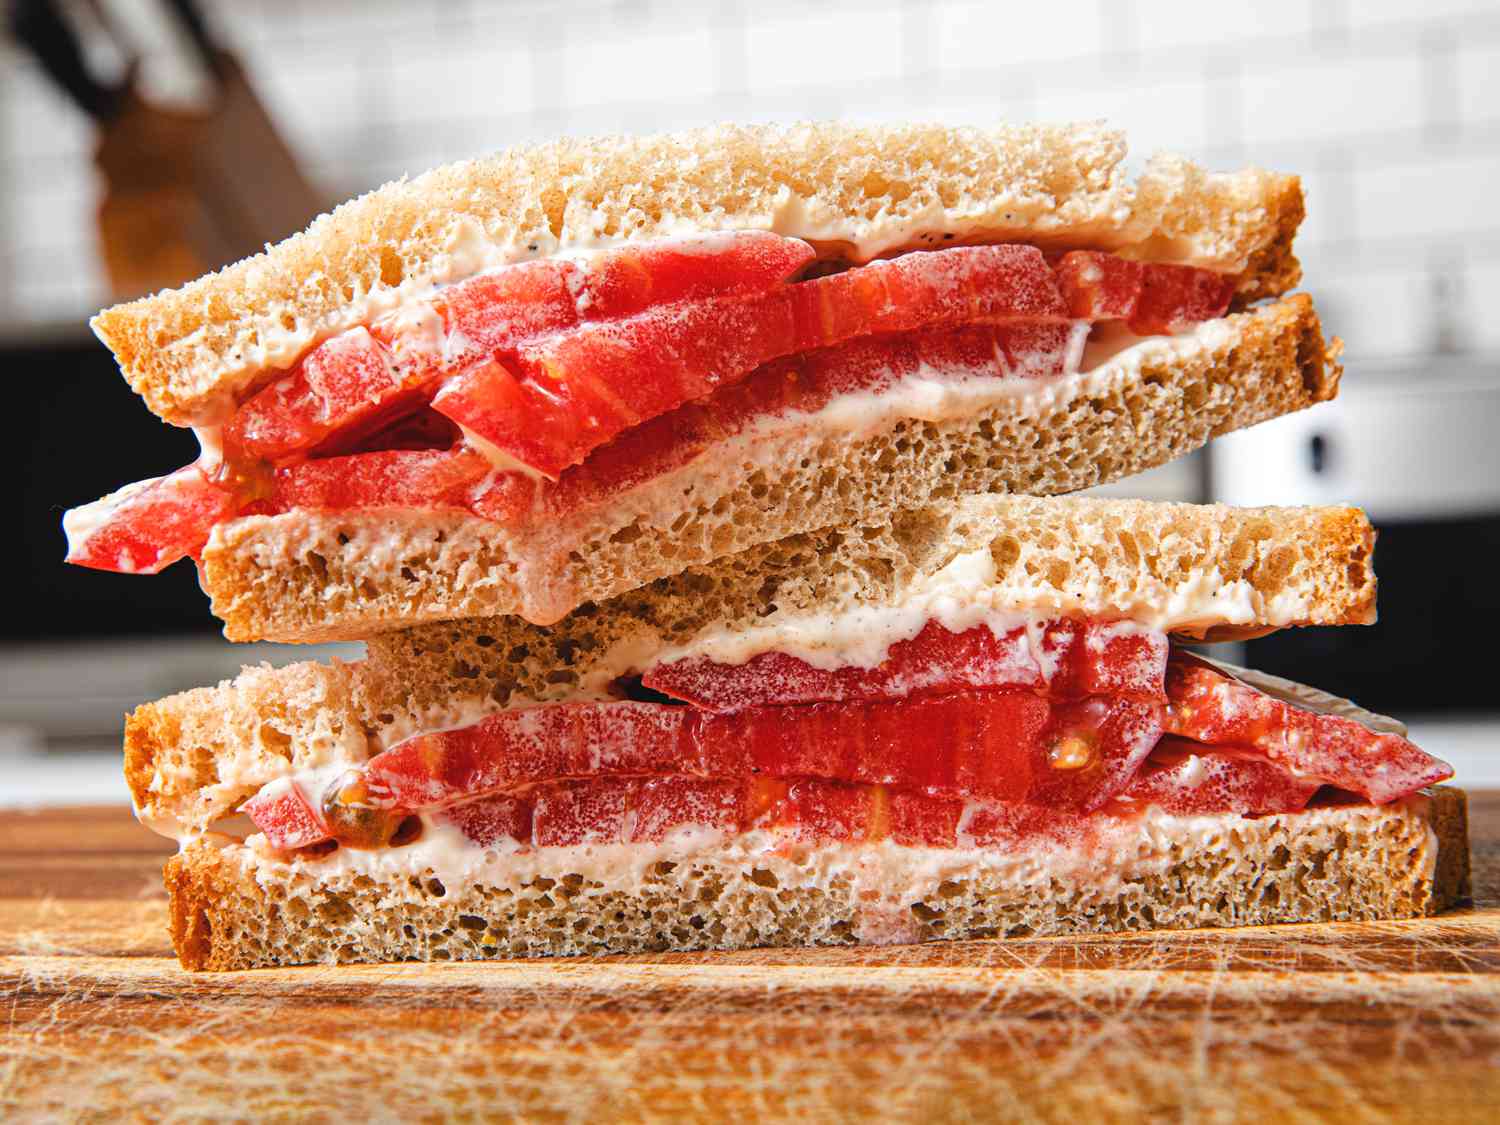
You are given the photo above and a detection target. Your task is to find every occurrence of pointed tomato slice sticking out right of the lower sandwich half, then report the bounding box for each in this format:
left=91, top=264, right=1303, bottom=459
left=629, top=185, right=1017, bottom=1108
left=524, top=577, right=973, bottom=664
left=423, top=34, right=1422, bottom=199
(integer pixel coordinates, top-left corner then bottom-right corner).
left=1166, top=651, right=1454, bottom=804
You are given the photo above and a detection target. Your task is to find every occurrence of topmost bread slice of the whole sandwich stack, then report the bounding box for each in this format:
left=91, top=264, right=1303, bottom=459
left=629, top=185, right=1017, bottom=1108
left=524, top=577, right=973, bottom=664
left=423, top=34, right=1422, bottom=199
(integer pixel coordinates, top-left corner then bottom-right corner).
left=93, top=125, right=1304, bottom=425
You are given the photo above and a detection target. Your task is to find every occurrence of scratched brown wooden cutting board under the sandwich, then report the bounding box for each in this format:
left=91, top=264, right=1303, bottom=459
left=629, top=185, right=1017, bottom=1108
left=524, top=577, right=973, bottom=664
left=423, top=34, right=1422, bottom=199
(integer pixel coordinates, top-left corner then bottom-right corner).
left=0, top=794, right=1500, bottom=1125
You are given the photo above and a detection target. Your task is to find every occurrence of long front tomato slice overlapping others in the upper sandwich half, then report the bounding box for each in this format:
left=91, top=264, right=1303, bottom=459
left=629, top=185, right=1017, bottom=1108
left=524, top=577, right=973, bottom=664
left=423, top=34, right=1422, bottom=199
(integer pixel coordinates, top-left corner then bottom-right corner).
left=434, top=246, right=1067, bottom=479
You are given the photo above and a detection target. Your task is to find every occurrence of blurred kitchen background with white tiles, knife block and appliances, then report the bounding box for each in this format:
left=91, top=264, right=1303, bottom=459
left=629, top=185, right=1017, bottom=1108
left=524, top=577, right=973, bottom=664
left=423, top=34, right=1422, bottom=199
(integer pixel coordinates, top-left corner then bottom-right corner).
left=0, top=0, right=1500, bottom=804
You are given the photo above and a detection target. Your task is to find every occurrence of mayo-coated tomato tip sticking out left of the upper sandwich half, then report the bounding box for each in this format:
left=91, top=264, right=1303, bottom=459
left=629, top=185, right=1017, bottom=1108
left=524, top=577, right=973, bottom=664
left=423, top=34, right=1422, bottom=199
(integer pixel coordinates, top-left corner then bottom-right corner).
left=63, top=464, right=240, bottom=575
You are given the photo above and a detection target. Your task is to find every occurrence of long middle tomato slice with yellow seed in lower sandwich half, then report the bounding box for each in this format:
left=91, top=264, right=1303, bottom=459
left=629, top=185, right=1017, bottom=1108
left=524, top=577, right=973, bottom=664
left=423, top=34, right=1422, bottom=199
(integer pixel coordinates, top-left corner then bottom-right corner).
left=366, top=692, right=1160, bottom=810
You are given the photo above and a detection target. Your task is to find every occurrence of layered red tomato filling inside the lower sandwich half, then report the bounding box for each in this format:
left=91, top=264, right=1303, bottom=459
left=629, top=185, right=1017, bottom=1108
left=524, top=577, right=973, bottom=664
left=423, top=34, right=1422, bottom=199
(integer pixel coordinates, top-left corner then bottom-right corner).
left=222, top=615, right=1452, bottom=870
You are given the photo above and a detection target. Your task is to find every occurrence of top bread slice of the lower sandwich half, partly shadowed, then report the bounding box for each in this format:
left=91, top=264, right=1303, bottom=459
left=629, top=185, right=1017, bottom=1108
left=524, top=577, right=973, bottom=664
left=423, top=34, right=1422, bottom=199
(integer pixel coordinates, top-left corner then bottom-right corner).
left=125, top=497, right=1376, bottom=836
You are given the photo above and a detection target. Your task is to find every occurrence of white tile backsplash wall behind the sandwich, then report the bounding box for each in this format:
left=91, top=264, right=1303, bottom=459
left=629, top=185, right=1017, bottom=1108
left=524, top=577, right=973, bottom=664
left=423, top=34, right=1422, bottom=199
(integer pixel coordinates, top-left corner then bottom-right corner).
left=0, top=0, right=1500, bottom=366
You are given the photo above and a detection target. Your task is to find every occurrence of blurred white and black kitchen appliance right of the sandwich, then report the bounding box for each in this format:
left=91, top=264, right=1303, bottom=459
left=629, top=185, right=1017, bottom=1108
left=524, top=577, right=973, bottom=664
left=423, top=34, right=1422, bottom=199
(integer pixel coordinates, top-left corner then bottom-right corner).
left=1209, top=356, right=1500, bottom=716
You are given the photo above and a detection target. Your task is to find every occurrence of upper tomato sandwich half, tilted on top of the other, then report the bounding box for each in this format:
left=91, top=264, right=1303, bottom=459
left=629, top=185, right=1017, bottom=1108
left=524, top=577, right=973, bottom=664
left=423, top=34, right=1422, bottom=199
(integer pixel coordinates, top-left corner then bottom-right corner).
left=66, top=125, right=1340, bottom=641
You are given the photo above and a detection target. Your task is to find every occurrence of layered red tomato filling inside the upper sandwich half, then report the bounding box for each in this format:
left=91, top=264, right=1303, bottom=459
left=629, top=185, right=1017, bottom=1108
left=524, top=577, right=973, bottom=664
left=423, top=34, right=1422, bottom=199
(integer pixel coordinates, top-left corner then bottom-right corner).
left=65, top=233, right=1236, bottom=572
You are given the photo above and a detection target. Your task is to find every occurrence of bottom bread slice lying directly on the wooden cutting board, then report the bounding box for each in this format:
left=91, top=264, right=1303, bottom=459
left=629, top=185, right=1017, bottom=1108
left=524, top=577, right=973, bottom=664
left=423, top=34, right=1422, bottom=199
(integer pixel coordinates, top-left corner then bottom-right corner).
left=167, top=786, right=1469, bottom=969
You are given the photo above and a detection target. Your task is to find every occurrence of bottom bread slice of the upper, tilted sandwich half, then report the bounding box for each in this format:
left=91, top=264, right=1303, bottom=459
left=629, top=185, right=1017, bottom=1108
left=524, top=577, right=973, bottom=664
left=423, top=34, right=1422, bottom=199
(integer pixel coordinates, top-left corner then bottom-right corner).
left=201, top=296, right=1341, bottom=641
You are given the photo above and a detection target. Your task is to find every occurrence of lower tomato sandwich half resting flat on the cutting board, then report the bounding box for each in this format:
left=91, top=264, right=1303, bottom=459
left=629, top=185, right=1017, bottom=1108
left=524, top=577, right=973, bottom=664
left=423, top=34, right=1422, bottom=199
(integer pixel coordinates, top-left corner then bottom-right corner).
left=126, top=495, right=1469, bottom=969
